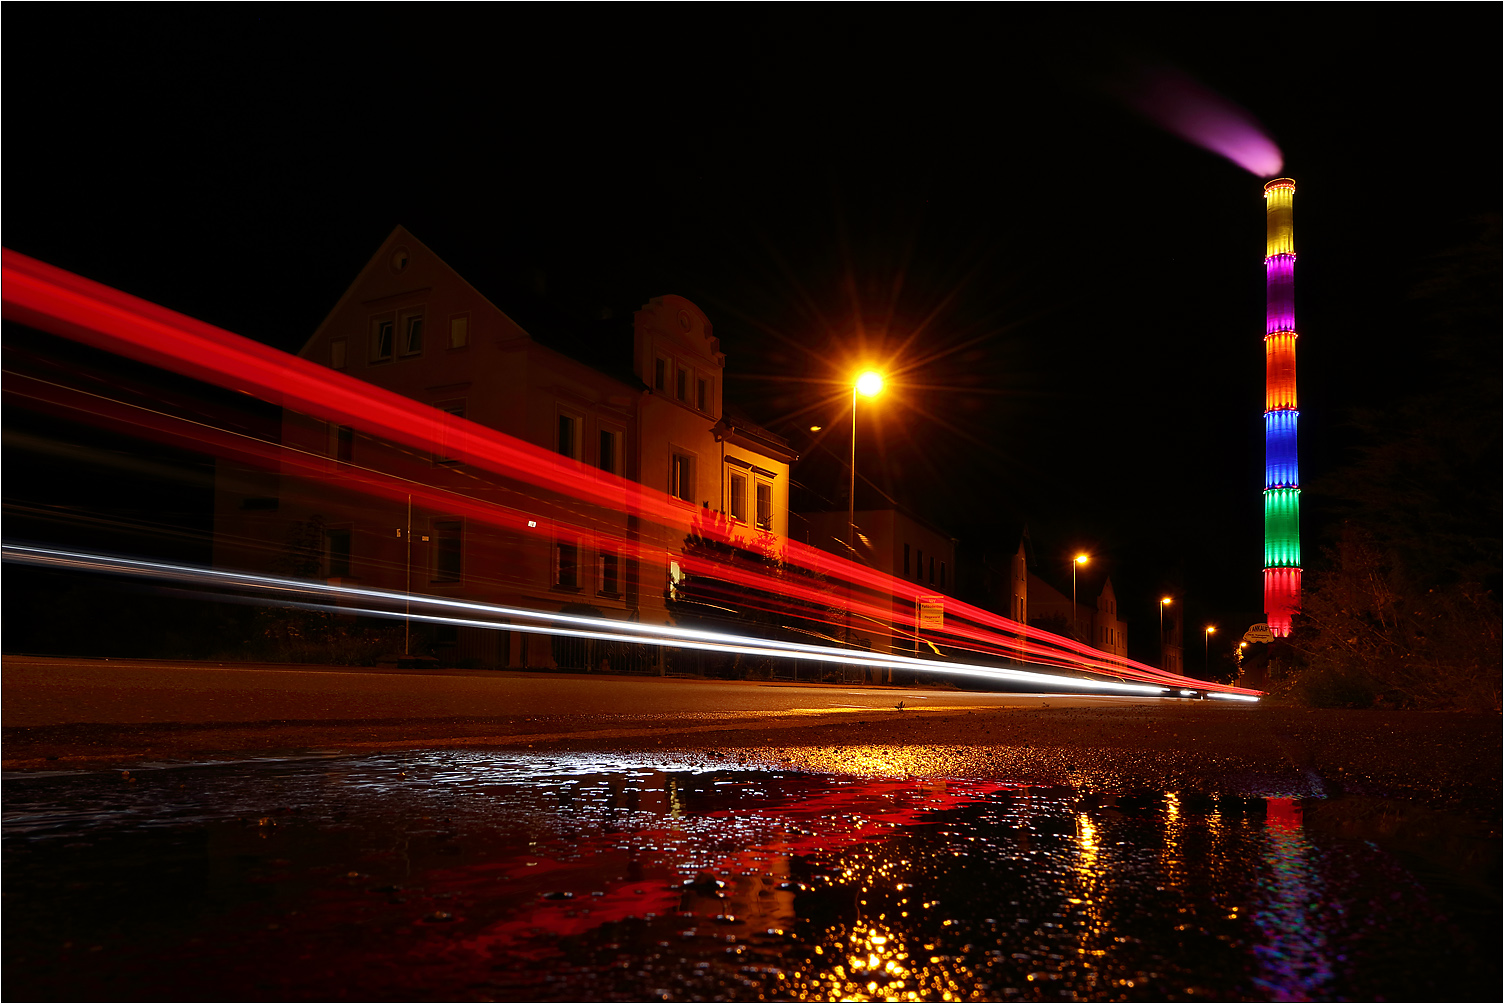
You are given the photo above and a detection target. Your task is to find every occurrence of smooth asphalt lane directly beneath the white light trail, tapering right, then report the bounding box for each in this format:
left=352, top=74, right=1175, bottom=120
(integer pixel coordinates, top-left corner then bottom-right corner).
left=3, top=657, right=1157, bottom=726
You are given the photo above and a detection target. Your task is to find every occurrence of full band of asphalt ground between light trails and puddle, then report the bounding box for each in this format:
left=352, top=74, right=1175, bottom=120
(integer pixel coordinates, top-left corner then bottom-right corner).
left=3, top=657, right=1499, bottom=845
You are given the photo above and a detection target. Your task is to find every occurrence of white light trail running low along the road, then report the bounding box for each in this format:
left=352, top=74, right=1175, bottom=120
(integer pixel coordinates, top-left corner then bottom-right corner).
left=3, top=544, right=1209, bottom=694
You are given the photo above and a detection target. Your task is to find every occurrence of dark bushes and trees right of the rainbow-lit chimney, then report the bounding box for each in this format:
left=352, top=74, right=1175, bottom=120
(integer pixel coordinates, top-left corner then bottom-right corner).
left=1271, top=218, right=1504, bottom=709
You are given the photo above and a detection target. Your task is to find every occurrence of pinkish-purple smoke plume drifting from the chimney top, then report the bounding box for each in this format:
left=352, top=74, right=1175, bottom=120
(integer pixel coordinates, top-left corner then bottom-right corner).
left=1117, top=66, right=1284, bottom=177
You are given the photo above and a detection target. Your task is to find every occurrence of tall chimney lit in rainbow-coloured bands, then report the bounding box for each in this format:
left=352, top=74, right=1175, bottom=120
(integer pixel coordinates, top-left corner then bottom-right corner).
left=1263, top=177, right=1301, bottom=637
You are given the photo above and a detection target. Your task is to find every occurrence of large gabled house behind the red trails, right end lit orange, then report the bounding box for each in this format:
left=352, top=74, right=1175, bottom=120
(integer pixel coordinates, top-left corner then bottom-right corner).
left=215, top=227, right=794, bottom=667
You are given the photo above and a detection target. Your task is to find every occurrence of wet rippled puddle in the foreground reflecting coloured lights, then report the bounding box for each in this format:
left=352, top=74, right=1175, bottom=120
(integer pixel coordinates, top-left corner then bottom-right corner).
left=5, top=748, right=1493, bottom=1001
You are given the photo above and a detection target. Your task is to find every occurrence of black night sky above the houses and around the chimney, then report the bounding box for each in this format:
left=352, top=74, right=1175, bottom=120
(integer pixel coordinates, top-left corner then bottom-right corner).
left=3, top=5, right=1501, bottom=655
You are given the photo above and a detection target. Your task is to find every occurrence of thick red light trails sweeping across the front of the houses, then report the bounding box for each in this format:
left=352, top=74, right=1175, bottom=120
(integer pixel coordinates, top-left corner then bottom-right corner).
left=0, top=249, right=1257, bottom=697
